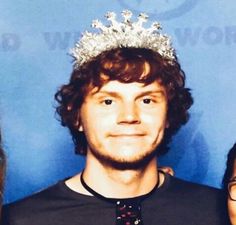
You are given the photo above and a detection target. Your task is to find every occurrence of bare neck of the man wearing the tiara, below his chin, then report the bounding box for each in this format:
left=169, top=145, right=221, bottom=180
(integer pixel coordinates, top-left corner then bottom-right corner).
left=66, top=153, right=164, bottom=198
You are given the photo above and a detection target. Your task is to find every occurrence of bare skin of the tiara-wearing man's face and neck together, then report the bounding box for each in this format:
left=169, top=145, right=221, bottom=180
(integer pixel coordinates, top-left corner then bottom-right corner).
left=66, top=81, right=168, bottom=198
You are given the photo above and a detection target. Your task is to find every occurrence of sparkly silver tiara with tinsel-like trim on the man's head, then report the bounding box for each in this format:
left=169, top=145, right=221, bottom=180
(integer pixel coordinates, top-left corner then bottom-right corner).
left=70, top=10, right=175, bottom=67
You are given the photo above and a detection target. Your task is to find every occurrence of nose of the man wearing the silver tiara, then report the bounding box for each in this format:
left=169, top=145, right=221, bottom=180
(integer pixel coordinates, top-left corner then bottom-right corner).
left=117, top=103, right=141, bottom=124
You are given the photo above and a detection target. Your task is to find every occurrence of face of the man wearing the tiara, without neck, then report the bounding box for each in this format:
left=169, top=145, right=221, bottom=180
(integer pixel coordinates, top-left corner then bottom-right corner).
left=79, top=81, right=167, bottom=169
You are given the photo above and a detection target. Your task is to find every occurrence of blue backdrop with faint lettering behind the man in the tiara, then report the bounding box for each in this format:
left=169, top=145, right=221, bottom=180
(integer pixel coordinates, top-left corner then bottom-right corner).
left=0, top=0, right=236, bottom=202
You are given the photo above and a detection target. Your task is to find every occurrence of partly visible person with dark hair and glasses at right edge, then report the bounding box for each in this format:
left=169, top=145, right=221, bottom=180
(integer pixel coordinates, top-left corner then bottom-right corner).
left=223, top=143, right=236, bottom=225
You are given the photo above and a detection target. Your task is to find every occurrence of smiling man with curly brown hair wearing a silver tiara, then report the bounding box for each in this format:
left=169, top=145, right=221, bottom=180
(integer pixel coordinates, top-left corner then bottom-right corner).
left=1, top=11, right=229, bottom=225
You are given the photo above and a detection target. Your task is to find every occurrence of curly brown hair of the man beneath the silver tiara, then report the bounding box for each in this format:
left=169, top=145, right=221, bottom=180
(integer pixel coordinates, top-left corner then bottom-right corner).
left=55, top=48, right=193, bottom=155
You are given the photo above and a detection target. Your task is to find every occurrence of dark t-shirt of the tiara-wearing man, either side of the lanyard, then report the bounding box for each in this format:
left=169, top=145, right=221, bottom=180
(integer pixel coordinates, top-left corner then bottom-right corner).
left=2, top=175, right=228, bottom=225
